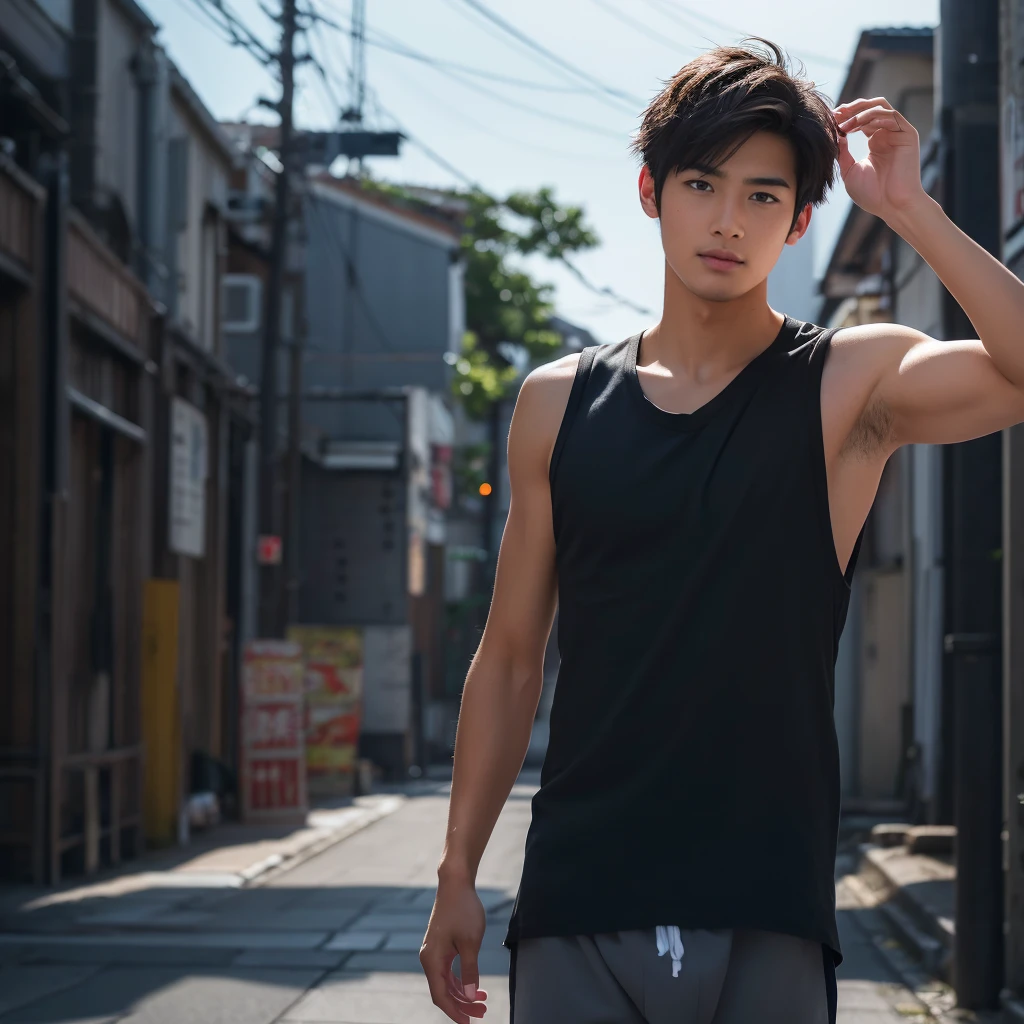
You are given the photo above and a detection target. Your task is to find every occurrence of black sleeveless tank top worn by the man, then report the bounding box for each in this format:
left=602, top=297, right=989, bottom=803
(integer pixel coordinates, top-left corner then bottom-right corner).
left=505, top=316, right=860, bottom=966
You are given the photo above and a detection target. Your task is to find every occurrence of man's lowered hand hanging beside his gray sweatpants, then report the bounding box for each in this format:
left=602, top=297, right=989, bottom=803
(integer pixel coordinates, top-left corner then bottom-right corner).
left=420, top=880, right=487, bottom=1024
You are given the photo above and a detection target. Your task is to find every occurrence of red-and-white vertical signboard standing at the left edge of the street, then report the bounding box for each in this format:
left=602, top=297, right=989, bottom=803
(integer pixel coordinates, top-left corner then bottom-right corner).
left=242, top=640, right=308, bottom=821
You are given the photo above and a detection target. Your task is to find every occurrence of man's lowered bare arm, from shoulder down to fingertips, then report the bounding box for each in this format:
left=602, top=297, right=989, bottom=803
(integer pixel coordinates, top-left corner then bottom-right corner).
left=420, top=355, right=579, bottom=1024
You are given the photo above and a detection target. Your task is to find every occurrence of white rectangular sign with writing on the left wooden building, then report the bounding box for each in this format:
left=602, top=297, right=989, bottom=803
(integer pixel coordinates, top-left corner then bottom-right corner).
left=168, top=398, right=209, bottom=558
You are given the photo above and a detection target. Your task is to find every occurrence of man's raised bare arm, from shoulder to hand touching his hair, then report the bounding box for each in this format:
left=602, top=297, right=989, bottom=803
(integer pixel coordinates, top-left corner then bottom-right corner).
left=830, top=96, right=1024, bottom=450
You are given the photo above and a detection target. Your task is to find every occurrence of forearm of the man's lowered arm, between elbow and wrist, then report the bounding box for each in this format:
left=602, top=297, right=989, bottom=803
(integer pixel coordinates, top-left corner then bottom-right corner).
left=437, top=650, right=542, bottom=882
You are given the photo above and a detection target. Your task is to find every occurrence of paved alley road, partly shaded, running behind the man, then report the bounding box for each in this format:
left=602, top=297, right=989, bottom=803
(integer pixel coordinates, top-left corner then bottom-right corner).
left=0, top=783, right=942, bottom=1024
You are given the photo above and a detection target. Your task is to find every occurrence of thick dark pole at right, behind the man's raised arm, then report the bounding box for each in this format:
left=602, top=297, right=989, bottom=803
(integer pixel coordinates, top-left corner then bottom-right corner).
left=940, top=0, right=1002, bottom=1010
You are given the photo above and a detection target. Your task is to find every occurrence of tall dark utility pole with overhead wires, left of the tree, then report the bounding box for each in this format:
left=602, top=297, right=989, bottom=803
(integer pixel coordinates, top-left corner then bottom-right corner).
left=259, top=0, right=297, bottom=637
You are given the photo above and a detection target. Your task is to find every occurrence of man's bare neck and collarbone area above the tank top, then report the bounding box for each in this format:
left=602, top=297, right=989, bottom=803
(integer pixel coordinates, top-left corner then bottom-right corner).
left=642, top=266, right=782, bottom=383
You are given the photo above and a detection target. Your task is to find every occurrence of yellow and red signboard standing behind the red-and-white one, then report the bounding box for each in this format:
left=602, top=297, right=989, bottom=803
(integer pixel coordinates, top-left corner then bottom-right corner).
left=288, top=626, right=364, bottom=796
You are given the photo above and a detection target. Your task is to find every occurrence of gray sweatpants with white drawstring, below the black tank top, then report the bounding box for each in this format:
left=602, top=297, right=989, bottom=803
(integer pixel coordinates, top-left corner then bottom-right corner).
left=512, top=928, right=835, bottom=1024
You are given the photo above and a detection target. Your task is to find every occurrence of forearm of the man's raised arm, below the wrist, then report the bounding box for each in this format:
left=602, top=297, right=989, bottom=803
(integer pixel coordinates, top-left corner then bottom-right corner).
left=886, top=196, right=1024, bottom=388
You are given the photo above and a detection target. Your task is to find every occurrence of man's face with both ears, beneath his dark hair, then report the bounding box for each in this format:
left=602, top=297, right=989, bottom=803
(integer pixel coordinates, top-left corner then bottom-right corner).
left=640, top=132, right=811, bottom=302
